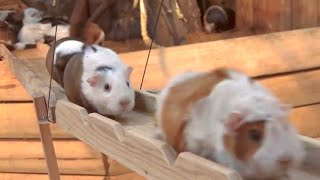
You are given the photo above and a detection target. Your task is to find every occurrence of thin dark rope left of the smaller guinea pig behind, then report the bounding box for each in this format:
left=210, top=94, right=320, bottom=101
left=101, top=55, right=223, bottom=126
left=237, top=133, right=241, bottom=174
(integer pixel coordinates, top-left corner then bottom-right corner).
left=47, top=0, right=60, bottom=121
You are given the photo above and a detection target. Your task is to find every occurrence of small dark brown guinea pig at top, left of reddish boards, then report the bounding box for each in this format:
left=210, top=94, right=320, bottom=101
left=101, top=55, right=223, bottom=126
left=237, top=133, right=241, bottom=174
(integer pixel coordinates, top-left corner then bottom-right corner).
left=203, top=6, right=235, bottom=33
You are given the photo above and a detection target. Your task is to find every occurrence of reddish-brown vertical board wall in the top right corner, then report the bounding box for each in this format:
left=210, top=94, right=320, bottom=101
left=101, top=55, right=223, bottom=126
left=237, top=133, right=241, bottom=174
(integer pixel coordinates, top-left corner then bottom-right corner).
left=236, top=0, right=320, bottom=33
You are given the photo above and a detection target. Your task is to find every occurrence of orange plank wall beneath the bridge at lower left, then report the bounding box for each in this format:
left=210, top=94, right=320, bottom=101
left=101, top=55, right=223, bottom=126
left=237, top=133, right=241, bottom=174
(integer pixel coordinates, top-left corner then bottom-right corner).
left=0, top=50, right=143, bottom=180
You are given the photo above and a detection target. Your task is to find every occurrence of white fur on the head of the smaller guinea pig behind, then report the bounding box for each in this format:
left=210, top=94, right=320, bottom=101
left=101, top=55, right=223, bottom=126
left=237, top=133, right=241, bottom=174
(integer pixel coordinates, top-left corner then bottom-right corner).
left=81, top=45, right=135, bottom=115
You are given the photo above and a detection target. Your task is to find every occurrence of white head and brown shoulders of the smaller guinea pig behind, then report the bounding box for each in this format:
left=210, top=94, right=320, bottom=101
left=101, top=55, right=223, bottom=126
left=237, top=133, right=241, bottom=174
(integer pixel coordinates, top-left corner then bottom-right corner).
left=63, top=45, right=135, bottom=116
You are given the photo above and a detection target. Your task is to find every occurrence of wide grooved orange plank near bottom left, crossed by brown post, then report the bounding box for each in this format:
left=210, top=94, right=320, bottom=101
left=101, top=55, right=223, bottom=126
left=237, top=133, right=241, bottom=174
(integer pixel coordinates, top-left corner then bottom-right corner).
left=0, top=140, right=132, bottom=176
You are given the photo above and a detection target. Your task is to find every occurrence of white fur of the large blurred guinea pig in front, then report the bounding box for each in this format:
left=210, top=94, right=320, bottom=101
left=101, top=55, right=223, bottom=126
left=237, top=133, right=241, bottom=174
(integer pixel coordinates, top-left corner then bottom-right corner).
left=156, top=70, right=305, bottom=178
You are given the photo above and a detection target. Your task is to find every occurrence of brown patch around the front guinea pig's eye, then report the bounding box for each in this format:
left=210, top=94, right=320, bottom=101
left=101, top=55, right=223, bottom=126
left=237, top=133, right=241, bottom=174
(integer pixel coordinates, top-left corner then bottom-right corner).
left=223, top=121, right=266, bottom=161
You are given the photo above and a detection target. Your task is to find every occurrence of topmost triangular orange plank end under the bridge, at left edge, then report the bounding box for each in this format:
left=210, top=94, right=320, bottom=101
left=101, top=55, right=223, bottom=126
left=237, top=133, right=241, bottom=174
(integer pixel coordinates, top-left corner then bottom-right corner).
left=0, top=61, right=32, bottom=102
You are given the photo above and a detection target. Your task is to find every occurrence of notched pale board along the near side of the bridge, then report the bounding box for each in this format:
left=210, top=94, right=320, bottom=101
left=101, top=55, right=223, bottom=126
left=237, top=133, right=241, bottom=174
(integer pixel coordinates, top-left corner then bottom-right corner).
left=56, top=100, right=241, bottom=180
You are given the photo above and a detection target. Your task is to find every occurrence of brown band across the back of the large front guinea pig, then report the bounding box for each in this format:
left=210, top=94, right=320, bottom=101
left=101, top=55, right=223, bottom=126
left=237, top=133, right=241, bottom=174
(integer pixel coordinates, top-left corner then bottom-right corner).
left=161, top=68, right=229, bottom=153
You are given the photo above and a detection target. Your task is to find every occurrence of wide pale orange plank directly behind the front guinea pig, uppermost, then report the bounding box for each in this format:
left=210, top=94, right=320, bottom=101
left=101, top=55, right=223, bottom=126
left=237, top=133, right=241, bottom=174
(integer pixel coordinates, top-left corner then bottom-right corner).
left=120, top=28, right=320, bottom=90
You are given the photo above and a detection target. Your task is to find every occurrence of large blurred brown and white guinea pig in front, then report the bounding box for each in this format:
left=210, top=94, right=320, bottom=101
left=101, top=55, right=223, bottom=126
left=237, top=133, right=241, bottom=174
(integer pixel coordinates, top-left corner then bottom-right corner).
left=156, top=68, right=305, bottom=179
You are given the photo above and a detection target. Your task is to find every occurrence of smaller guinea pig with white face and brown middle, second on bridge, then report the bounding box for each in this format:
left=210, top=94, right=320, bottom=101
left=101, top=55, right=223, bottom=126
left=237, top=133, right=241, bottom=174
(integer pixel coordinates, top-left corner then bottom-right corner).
left=47, top=39, right=135, bottom=117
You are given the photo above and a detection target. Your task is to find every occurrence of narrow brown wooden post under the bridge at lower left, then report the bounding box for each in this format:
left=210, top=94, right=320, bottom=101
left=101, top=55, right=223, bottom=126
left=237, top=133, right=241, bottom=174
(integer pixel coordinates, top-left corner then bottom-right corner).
left=33, top=96, right=60, bottom=180
